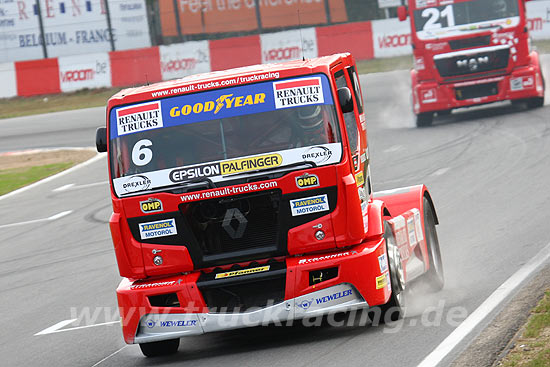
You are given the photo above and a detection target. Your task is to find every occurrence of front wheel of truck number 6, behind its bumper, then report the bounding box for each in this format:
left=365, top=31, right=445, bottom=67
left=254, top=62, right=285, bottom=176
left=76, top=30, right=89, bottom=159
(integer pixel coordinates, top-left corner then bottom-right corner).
left=380, top=222, right=405, bottom=323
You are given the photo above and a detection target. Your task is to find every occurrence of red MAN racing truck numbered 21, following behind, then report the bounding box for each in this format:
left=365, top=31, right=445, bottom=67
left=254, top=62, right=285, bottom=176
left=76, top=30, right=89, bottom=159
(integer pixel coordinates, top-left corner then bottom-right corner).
left=398, top=0, right=545, bottom=126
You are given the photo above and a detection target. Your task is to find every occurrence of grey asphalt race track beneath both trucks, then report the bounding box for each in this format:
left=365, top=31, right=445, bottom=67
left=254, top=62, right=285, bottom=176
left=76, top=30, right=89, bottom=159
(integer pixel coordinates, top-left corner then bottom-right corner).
left=0, top=58, right=550, bottom=367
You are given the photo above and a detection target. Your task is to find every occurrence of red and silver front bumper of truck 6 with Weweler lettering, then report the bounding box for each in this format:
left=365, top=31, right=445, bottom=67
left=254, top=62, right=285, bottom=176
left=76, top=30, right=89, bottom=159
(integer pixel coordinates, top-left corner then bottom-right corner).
left=117, top=239, right=391, bottom=344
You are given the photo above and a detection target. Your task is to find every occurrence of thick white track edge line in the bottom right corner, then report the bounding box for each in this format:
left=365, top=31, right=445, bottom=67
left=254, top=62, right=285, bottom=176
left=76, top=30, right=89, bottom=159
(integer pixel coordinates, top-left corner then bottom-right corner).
left=417, top=243, right=550, bottom=367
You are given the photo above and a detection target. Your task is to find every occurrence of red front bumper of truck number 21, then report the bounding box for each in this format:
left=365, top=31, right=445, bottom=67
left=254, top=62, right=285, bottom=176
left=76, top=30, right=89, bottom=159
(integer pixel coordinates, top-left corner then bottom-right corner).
left=413, top=66, right=544, bottom=115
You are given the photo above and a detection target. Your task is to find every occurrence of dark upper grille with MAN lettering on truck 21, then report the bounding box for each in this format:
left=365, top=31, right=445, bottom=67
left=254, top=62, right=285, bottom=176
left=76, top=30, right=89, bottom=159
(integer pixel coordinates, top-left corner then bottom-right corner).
left=434, top=45, right=510, bottom=78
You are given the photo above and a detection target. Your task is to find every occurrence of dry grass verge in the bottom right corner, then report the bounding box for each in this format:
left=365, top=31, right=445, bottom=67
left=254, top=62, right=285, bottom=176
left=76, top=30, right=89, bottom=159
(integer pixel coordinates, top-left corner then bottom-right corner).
left=498, top=290, right=550, bottom=367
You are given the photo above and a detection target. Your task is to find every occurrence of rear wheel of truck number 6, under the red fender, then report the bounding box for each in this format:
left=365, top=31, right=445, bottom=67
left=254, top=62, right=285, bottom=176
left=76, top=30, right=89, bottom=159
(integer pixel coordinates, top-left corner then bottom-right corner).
left=424, top=198, right=445, bottom=292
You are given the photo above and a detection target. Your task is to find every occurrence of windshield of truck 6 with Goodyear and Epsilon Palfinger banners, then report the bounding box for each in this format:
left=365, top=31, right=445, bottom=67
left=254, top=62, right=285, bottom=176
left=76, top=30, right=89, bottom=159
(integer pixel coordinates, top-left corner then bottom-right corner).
left=109, top=74, right=342, bottom=196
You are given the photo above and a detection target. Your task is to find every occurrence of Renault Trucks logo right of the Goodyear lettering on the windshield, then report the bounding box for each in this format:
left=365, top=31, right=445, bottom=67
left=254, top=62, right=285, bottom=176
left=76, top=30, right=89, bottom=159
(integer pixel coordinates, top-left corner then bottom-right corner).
left=273, top=77, right=324, bottom=108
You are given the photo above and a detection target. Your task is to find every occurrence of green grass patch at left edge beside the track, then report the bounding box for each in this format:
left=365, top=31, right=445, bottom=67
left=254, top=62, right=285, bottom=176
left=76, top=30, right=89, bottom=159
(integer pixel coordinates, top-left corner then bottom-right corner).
left=0, top=162, right=75, bottom=195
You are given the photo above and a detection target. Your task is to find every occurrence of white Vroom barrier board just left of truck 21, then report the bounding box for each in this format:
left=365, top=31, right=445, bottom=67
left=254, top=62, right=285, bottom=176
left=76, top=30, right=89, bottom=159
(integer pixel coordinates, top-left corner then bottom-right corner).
left=372, top=18, right=412, bottom=58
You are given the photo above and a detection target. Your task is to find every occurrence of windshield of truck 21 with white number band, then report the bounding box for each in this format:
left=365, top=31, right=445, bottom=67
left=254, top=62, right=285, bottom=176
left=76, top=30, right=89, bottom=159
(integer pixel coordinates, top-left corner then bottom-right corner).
left=414, top=0, right=519, bottom=39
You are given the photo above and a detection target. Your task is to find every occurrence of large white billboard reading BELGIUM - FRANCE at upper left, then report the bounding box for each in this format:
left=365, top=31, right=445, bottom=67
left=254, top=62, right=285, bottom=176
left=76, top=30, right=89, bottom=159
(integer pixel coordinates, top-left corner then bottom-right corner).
left=0, top=0, right=151, bottom=62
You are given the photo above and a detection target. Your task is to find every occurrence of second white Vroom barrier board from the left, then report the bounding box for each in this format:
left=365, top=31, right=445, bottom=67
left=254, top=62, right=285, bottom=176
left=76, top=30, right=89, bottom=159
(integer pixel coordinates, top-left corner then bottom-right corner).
left=159, top=41, right=210, bottom=80
